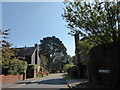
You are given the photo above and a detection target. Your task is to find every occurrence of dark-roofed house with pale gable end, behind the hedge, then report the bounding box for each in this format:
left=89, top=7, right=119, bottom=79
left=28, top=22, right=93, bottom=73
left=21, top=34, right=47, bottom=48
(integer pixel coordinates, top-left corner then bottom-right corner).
left=15, top=44, right=40, bottom=77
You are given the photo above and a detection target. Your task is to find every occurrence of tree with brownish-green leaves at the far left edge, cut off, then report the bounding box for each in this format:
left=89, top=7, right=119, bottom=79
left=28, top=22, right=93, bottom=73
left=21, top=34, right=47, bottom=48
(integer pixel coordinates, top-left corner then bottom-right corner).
left=0, top=29, right=13, bottom=74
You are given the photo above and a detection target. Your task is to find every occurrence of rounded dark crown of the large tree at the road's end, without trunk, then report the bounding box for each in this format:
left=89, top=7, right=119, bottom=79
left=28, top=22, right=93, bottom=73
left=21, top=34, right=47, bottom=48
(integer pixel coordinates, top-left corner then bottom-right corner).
left=40, top=36, right=66, bottom=59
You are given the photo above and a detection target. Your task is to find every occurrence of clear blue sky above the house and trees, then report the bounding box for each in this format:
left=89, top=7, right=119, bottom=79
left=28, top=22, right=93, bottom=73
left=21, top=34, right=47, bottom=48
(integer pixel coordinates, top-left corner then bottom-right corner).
left=2, top=2, right=75, bottom=56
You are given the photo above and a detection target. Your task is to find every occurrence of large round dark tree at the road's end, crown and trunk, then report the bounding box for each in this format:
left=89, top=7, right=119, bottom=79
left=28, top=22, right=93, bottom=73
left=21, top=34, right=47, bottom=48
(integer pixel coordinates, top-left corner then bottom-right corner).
left=40, top=36, right=67, bottom=70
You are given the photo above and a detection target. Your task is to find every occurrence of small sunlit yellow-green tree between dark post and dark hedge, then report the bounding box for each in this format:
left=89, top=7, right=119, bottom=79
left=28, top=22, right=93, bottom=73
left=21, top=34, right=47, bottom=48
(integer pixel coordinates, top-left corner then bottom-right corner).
left=78, top=37, right=95, bottom=81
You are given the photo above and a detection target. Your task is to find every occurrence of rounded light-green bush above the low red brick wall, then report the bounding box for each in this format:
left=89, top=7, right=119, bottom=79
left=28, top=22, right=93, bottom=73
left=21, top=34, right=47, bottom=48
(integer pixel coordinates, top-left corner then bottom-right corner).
left=8, top=58, right=27, bottom=75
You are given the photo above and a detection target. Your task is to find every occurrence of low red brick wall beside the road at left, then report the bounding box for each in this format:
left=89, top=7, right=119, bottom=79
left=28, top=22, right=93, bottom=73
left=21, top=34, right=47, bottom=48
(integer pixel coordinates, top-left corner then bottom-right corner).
left=0, top=74, right=23, bottom=83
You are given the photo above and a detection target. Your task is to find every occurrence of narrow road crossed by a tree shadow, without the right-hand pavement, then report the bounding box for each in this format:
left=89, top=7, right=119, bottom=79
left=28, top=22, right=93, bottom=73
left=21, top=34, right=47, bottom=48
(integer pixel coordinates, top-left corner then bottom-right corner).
left=3, top=73, right=69, bottom=89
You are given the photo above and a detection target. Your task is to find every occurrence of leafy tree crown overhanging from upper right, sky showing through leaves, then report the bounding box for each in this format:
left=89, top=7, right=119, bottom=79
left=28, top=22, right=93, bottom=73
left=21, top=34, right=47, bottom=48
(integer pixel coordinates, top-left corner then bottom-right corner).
left=62, top=1, right=120, bottom=44
